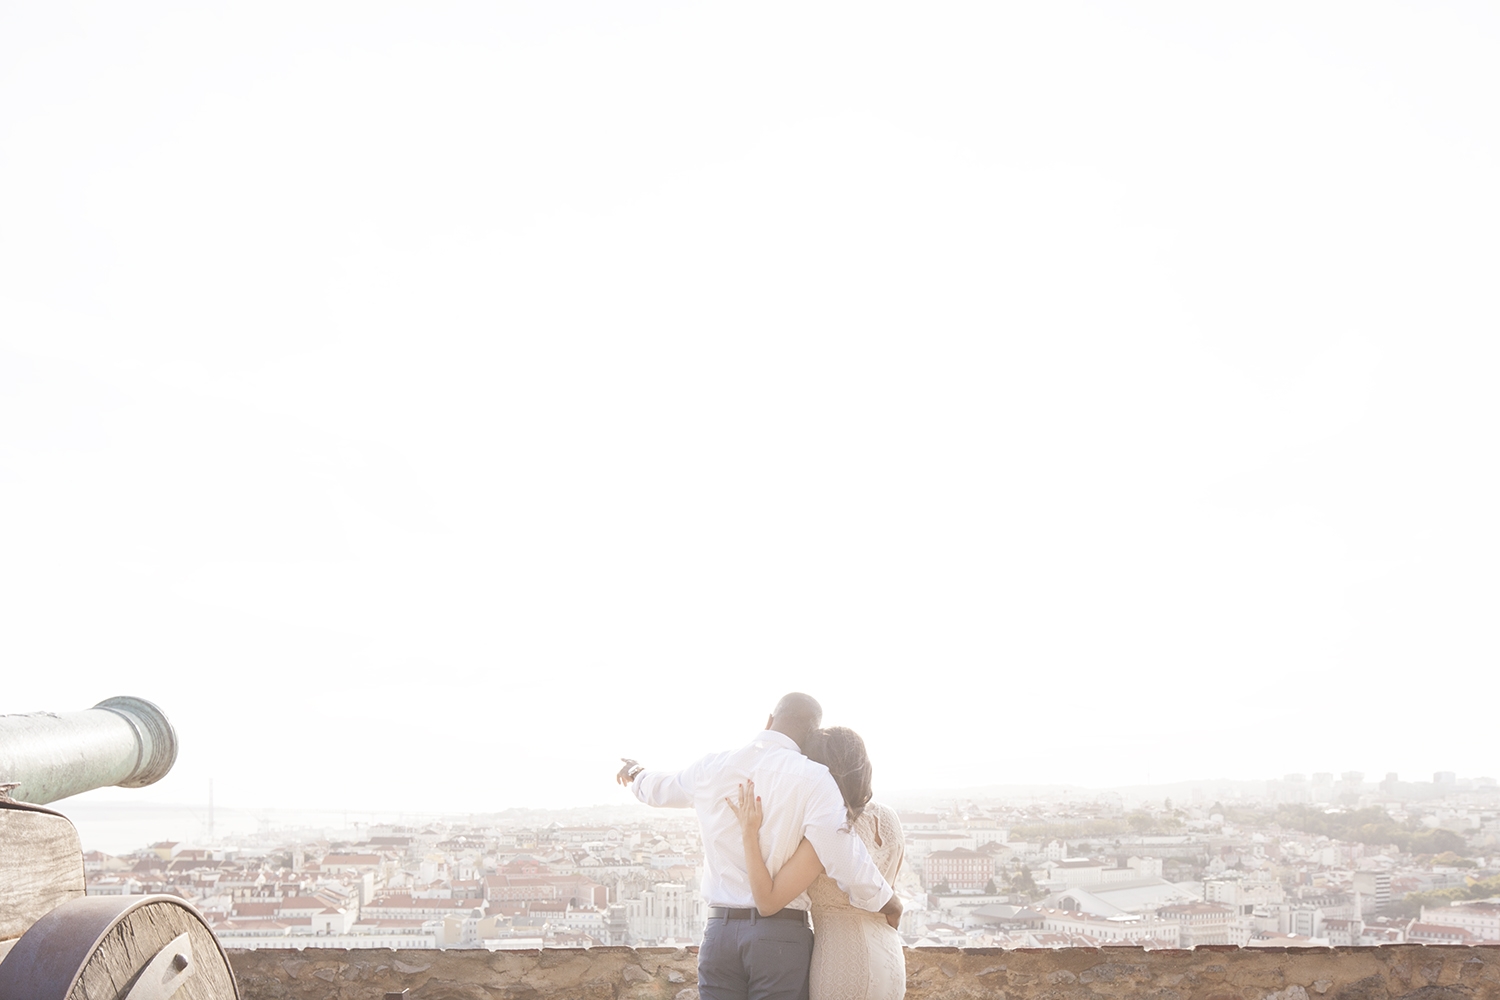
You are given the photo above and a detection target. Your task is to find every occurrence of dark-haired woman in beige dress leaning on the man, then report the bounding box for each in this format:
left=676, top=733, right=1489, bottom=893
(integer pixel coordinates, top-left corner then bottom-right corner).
left=725, top=726, right=906, bottom=1000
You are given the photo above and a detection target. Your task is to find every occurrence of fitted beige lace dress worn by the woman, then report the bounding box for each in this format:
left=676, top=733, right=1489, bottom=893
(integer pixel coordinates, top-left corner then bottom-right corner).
left=807, top=802, right=906, bottom=1000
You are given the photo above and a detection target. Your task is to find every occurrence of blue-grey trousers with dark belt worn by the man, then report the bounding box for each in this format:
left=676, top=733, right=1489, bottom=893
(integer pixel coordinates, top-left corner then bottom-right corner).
left=698, top=918, right=813, bottom=1000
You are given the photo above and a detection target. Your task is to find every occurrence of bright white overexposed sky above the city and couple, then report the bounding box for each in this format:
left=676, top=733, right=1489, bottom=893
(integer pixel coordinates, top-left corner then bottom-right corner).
left=0, top=0, right=1500, bottom=810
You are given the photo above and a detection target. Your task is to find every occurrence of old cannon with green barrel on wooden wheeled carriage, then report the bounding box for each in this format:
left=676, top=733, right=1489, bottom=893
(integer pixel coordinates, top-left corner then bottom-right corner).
left=0, top=697, right=239, bottom=1000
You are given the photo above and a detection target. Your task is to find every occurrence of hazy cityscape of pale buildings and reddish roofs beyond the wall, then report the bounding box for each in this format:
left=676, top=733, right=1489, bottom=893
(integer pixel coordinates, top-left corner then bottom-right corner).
left=84, top=772, right=1500, bottom=951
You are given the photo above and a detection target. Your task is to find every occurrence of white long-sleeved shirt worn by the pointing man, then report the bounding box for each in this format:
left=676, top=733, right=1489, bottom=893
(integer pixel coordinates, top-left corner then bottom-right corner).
left=630, top=730, right=893, bottom=913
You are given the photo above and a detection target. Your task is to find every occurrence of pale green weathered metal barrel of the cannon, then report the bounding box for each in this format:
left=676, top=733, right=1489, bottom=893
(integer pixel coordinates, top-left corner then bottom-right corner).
left=0, top=697, right=177, bottom=805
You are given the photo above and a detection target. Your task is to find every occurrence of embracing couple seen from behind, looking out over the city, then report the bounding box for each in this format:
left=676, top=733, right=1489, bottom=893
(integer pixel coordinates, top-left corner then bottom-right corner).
left=617, top=693, right=906, bottom=1000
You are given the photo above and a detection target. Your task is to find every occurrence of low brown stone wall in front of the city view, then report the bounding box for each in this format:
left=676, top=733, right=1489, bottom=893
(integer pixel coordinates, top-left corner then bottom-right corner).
left=230, top=945, right=1500, bottom=1000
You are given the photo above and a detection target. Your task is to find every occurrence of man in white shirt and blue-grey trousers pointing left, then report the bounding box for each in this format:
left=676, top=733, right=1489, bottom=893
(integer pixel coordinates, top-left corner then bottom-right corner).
left=615, top=693, right=902, bottom=1000
